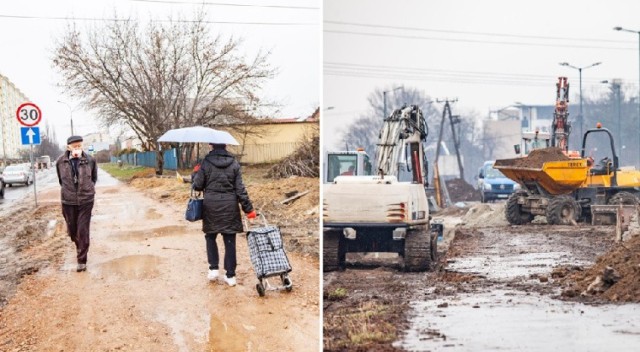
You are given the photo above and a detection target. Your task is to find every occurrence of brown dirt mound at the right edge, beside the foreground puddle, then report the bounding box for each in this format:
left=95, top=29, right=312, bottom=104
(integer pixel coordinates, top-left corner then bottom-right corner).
left=554, top=236, right=640, bottom=302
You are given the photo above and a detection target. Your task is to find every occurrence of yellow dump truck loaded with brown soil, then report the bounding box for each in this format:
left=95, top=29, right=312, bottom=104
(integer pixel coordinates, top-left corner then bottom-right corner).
left=494, top=128, right=640, bottom=225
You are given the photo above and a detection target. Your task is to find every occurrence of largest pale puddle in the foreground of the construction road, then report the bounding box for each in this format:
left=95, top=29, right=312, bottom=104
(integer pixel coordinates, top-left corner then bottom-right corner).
left=394, top=290, right=640, bottom=351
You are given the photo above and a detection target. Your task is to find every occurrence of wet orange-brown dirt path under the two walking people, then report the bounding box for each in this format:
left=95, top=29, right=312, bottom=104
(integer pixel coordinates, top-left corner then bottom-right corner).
left=0, top=170, right=320, bottom=351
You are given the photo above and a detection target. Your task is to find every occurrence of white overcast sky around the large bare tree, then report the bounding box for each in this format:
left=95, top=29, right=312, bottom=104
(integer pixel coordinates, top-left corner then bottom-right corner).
left=0, top=0, right=321, bottom=145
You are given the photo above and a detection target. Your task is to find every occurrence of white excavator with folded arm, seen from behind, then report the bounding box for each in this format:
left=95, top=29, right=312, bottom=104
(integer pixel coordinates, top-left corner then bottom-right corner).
left=323, top=105, right=442, bottom=271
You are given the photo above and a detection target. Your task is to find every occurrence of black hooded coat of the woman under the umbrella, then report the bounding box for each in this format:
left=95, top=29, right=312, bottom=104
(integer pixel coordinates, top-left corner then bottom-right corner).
left=193, top=150, right=253, bottom=233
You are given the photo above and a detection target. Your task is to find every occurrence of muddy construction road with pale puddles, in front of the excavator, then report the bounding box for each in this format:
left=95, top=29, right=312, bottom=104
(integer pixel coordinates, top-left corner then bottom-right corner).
left=323, top=205, right=640, bottom=351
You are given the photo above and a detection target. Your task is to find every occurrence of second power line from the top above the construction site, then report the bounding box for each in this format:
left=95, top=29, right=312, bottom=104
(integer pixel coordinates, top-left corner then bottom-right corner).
left=323, top=29, right=638, bottom=51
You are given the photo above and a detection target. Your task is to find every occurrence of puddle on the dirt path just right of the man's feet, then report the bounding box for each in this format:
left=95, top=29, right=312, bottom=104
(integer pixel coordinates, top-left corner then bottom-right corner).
left=99, top=255, right=162, bottom=279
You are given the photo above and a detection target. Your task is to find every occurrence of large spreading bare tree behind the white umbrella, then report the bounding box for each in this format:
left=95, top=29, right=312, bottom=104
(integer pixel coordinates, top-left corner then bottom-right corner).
left=53, top=13, right=275, bottom=174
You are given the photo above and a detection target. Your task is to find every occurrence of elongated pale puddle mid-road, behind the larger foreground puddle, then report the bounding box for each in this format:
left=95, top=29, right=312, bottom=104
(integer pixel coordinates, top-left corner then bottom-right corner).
left=447, top=252, right=591, bottom=280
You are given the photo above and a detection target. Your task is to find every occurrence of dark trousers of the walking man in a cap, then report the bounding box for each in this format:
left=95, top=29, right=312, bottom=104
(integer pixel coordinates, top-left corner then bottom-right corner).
left=62, top=202, right=93, bottom=264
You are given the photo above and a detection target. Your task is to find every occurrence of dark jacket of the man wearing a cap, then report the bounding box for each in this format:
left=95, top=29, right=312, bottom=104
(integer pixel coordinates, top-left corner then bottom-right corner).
left=56, top=151, right=98, bottom=205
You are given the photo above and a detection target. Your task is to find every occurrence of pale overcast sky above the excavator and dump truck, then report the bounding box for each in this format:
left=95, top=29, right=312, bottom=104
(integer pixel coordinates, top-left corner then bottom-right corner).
left=323, top=0, right=640, bottom=148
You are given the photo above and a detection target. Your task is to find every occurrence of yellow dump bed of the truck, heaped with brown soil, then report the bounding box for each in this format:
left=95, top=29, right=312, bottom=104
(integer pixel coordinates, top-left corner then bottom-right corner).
left=493, top=148, right=589, bottom=195
